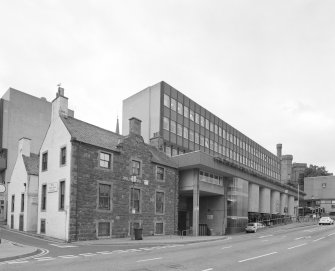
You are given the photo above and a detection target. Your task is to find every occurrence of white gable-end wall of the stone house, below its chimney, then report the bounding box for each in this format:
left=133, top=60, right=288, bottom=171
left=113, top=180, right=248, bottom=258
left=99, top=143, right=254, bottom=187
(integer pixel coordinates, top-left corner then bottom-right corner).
left=37, top=118, right=71, bottom=240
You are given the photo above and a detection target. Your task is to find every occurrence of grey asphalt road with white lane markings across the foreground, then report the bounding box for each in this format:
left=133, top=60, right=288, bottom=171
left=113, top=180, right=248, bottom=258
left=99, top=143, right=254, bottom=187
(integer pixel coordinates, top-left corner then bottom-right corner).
left=0, top=225, right=335, bottom=271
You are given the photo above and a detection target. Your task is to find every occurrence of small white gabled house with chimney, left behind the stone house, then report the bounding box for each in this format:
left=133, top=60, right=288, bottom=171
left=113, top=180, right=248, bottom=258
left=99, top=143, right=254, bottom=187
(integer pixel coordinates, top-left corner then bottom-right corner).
left=7, top=138, right=39, bottom=232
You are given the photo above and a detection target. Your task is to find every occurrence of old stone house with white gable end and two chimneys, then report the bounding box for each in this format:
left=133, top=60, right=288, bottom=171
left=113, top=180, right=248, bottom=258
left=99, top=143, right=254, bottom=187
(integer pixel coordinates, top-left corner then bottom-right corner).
left=37, top=88, right=178, bottom=241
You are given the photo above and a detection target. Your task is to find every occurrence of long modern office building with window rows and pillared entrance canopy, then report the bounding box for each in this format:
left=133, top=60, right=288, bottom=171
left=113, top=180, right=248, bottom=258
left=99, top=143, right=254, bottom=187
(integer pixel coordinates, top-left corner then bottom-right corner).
left=122, top=82, right=297, bottom=235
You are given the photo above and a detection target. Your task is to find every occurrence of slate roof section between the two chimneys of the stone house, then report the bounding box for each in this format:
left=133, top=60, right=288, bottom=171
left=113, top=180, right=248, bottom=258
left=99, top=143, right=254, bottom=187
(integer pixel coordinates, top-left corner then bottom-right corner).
left=61, top=116, right=122, bottom=151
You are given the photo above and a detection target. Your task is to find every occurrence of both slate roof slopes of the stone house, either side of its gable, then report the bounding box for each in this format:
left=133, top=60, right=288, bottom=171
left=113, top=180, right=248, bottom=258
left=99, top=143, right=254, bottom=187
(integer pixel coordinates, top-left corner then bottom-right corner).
left=61, top=116, right=177, bottom=168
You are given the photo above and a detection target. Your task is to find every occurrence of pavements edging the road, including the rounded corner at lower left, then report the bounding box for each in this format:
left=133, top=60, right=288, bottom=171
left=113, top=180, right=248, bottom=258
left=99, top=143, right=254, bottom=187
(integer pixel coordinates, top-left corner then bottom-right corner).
left=0, top=222, right=317, bottom=262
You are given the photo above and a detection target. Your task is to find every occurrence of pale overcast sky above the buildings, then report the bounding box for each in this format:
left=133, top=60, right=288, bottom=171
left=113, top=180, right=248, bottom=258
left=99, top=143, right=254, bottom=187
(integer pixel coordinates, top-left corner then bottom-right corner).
left=0, top=0, right=335, bottom=174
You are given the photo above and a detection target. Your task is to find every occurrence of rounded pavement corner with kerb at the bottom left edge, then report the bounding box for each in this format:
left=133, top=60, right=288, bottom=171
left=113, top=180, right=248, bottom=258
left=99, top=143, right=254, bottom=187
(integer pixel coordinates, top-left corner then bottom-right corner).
left=0, top=239, right=41, bottom=262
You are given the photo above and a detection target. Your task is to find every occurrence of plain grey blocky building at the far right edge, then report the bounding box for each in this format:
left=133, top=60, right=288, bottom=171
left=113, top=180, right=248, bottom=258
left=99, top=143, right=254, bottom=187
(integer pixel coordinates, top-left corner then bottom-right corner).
left=304, top=176, right=335, bottom=216
